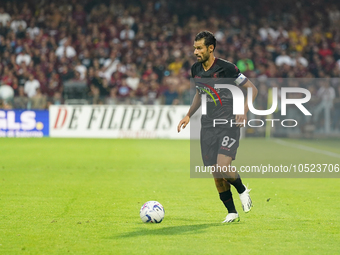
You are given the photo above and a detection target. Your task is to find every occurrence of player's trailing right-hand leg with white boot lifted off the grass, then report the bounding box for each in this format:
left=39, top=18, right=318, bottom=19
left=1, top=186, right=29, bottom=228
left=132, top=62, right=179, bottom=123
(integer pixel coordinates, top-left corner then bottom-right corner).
left=217, top=154, right=252, bottom=212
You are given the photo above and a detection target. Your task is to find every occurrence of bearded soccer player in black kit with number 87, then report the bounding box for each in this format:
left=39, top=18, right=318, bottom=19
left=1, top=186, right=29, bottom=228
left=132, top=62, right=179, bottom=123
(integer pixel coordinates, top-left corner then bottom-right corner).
left=177, top=31, right=257, bottom=223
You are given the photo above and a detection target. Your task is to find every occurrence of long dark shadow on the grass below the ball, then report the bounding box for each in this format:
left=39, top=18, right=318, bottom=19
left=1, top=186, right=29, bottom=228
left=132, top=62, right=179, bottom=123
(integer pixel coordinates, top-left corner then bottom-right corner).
left=116, top=223, right=225, bottom=238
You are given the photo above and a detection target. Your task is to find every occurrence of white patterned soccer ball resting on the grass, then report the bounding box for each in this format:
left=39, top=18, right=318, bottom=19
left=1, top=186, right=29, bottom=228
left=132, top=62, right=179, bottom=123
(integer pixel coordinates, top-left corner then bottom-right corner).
left=139, top=201, right=164, bottom=223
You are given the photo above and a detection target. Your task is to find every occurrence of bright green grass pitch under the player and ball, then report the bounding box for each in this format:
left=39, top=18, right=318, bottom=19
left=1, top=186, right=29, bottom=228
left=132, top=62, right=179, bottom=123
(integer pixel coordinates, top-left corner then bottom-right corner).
left=0, top=138, right=340, bottom=255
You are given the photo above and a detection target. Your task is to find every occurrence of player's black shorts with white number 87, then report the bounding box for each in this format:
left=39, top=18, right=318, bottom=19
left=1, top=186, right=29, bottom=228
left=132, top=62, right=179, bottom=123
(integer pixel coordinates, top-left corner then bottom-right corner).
left=201, top=127, right=240, bottom=166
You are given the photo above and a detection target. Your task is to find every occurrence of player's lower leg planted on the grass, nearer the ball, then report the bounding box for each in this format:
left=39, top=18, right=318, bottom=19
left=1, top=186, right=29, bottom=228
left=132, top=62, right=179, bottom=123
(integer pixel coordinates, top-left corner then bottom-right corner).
left=213, top=165, right=240, bottom=223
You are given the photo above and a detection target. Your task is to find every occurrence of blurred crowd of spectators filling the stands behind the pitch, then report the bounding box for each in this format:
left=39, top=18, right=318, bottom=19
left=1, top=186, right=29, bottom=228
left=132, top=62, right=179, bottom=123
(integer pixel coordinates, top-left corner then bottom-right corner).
left=0, top=0, right=340, bottom=130
